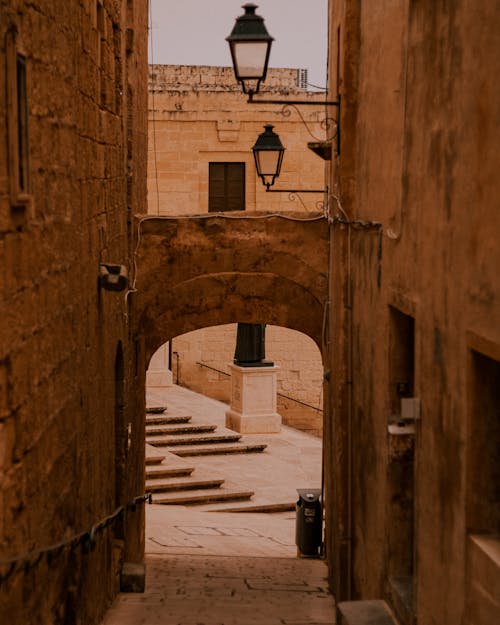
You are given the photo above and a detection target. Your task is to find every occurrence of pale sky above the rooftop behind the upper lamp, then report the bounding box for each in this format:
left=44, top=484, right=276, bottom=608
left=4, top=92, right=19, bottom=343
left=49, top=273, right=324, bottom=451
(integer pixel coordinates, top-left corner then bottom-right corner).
left=149, top=0, right=328, bottom=87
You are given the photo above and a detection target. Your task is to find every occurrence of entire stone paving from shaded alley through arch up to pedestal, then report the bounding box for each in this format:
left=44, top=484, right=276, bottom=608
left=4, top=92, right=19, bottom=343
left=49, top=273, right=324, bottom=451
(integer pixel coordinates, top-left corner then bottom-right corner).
left=103, top=386, right=335, bottom=625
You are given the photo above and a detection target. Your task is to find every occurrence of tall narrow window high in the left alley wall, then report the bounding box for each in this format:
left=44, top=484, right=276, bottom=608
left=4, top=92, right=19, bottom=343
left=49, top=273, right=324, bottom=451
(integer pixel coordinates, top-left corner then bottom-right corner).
left=6, top=29, right=29, bottom=206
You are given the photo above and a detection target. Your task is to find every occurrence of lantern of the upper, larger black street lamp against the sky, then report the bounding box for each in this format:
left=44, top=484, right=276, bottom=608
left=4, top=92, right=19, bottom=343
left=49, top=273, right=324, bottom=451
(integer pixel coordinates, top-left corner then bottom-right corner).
left=226, top=3, right=273, bottom=98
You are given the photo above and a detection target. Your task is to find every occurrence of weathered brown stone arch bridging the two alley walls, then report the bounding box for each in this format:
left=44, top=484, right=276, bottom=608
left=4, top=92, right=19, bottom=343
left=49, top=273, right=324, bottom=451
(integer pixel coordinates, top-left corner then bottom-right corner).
left=133, top=213, right=328, bottom=357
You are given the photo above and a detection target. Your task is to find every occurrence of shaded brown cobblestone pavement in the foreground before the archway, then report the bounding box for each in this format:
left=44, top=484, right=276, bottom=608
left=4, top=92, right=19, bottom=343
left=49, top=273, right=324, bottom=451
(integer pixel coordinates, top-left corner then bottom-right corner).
left=103, top=555, right=335, bottom=625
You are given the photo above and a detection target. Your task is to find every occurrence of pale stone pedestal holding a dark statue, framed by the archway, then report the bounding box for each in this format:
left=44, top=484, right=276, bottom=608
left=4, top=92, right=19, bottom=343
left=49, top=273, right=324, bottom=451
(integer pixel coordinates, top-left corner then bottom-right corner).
left=226, top=364, right=281, bottom=434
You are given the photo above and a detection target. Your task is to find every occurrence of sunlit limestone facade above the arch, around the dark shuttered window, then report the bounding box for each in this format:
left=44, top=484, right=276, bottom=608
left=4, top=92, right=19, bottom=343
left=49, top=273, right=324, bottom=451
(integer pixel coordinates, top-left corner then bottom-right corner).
left=148, top=65, right=325, bottom=215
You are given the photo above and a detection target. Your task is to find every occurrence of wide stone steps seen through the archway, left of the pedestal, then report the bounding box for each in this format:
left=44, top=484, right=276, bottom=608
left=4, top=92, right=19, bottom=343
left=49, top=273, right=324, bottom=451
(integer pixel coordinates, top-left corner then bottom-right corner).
left=146, top=407, right=266, bottom=505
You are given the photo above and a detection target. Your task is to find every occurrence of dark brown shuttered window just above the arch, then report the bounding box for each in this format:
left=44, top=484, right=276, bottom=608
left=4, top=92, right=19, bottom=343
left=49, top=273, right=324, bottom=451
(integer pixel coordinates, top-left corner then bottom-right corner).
left=208, top=163, right=245, bottom=213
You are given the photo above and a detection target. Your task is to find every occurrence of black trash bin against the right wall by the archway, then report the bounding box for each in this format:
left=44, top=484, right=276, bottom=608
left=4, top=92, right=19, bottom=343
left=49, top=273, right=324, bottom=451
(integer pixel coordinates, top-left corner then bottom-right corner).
left=295, top=488, right=323, bottom=557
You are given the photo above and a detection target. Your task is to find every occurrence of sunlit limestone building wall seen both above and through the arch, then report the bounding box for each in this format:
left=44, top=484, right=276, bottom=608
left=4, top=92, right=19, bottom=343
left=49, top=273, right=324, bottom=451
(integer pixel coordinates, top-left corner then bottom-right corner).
left=148, top=65, right=324, bottom=433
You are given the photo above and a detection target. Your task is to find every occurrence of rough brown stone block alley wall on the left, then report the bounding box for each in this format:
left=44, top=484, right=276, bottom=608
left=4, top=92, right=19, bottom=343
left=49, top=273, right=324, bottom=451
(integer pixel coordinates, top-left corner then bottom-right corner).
left=0, top=0, right=147, bottom=625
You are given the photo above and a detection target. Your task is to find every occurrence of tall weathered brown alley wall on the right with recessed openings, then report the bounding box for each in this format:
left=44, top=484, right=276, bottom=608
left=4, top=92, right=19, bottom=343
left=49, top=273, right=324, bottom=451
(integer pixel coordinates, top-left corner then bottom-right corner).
left=327, top=0, right=500, bottom=625
